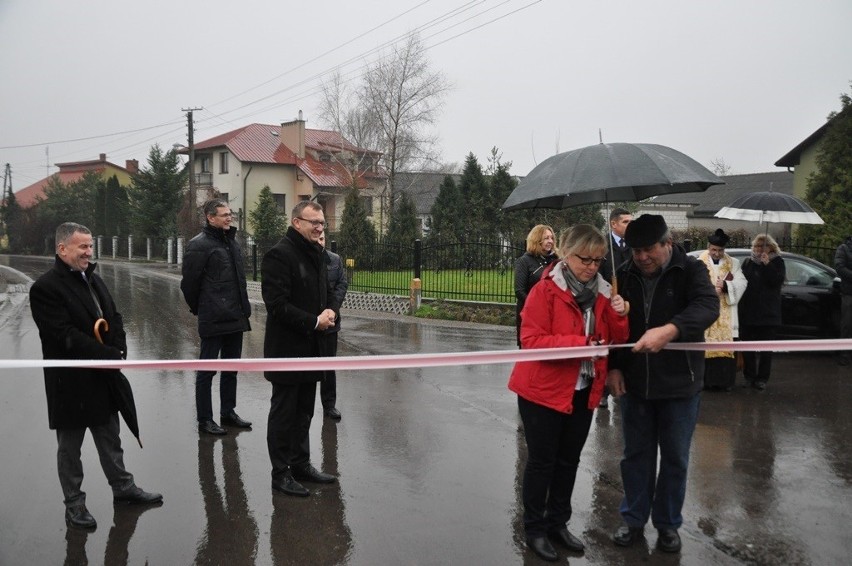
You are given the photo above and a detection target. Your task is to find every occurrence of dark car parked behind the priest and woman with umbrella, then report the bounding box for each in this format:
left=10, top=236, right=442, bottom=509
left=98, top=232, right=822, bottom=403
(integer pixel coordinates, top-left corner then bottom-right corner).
left=689, top=248, right=840, bottom=340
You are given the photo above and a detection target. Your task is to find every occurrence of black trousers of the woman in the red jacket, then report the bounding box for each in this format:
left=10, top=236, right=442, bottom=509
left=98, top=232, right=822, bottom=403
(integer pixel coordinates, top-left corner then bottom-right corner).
left=518, top=387, right=592, bottom=537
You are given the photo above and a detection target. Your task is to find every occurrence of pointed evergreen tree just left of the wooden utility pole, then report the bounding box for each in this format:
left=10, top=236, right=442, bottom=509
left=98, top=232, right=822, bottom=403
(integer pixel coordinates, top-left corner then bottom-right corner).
left=128, top=145, right=187, bottom=239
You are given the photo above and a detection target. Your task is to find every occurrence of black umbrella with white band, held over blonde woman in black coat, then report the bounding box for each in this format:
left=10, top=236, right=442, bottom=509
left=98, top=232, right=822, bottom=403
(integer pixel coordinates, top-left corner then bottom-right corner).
left=713, top=191, right=824, bottom=224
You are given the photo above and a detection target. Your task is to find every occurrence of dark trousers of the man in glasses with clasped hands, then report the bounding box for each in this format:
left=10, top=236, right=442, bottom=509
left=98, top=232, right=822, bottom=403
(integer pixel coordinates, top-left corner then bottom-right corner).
left=266, top=381, right=317, bottom=479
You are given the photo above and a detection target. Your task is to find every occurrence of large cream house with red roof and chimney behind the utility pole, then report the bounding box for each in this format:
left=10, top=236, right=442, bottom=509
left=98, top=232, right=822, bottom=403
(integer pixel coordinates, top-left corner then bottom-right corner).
left=190, top=116, right=387, bottom=233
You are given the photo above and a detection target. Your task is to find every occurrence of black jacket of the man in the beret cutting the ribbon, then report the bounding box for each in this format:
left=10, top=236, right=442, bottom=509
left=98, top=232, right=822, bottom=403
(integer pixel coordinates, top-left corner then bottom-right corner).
left=610, top=244, right=719, bottom=399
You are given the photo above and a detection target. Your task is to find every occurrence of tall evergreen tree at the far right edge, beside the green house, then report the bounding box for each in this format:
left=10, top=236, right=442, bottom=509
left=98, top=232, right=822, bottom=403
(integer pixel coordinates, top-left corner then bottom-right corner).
left=799, top=83, right=852, bottom=249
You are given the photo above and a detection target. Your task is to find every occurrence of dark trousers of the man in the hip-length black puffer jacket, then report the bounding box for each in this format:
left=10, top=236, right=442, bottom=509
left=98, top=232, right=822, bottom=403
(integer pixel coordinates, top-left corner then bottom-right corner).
left=195, top=332, right=243, bottom=422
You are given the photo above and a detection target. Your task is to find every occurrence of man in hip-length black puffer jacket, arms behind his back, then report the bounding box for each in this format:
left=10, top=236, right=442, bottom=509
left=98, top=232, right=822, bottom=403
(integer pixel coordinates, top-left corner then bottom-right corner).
left=180, top=199, right=251, bottom=435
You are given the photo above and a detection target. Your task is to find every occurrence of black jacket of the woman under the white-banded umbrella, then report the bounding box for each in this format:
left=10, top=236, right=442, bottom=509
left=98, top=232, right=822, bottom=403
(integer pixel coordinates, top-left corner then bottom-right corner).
left=737, top=255, right=786, bottom=327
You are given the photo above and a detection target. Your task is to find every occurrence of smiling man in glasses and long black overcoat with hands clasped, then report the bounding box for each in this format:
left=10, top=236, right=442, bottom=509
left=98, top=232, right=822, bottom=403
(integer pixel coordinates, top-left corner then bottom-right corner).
left=261, top=201, right=336, bottom=497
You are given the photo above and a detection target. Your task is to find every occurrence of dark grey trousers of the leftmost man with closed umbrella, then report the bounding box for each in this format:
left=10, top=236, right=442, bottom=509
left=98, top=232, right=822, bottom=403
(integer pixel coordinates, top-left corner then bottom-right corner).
left=56, top=413, right=134, bottom=507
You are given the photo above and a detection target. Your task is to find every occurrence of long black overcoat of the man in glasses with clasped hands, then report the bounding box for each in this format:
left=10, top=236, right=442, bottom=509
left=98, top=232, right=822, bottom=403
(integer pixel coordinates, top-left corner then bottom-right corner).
left=260, top=226, right=333, bottom=384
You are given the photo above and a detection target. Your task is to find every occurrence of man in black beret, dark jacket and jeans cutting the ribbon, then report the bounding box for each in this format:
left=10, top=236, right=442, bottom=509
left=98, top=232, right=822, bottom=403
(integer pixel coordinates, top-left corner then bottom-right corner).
left=607, top=214, right=719, bottom=552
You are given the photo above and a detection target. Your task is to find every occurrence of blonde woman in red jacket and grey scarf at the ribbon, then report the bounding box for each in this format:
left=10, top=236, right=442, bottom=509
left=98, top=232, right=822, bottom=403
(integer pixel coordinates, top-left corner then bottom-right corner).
left=509, top=224, right=628, bottom=561
